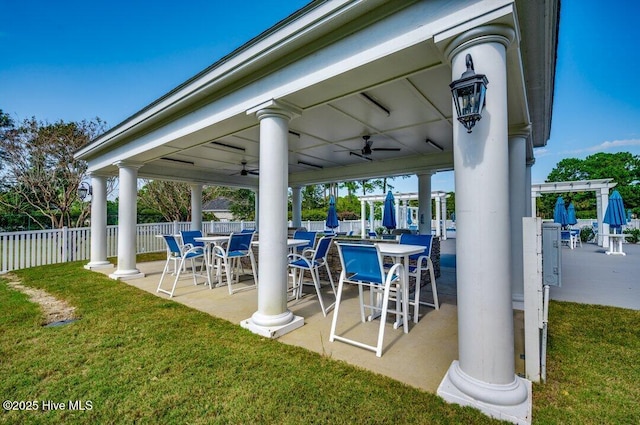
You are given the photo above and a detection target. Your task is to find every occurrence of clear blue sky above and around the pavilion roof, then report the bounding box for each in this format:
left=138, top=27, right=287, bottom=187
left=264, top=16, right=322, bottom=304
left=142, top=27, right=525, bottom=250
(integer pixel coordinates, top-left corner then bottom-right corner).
left=0, top=0, right=640, bottom=191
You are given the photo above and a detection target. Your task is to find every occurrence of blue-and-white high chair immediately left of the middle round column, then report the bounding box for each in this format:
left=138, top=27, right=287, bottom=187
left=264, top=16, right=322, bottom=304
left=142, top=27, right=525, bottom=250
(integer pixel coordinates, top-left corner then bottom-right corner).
left=213, top=233, right=258, bottom=294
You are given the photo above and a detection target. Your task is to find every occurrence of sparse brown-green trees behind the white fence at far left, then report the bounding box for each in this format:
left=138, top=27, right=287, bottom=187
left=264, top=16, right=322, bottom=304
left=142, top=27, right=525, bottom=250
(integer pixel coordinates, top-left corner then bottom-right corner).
left=0, top=115, right=105, bottom=228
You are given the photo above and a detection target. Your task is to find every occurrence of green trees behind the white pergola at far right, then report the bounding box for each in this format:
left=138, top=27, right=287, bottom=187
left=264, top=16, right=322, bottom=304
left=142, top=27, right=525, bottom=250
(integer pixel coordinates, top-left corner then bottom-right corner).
left=540, top=152, right=640, bottom=218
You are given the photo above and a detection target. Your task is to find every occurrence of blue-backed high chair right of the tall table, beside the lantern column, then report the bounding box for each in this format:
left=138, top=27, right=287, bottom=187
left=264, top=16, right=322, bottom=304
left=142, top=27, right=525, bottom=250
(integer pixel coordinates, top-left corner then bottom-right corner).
left=396, top=234, right=440, bottom=323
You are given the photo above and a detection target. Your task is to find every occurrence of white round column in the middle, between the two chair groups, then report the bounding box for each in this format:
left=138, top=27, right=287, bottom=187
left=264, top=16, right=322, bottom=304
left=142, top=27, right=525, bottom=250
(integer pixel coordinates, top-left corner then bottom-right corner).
left=241, top=97, right=304, bottom=338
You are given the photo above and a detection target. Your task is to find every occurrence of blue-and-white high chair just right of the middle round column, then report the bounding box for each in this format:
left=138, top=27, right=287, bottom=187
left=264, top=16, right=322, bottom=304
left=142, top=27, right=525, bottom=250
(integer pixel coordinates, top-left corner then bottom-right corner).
left=288, top=236, right=336, bottom=317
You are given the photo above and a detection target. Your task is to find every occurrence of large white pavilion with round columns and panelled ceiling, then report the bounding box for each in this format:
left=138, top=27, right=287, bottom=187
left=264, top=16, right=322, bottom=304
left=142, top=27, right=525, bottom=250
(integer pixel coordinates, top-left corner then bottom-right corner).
left=76, top=0, right=559, bottom=422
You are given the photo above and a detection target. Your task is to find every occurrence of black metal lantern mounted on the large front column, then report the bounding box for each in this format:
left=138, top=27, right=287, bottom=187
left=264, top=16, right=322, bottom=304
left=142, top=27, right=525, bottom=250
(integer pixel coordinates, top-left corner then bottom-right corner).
left=449, top=54, right=489, bottom=133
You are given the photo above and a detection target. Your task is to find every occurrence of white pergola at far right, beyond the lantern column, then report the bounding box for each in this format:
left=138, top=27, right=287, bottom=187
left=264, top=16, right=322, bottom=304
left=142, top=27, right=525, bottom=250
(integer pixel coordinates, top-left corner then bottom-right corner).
left=531, top=179, right=617, bottom=246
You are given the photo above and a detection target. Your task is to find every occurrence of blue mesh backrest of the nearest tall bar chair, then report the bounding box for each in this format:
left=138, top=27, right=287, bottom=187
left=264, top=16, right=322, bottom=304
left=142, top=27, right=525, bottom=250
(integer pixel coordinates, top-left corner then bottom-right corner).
left=336, top=242, right=385, bottom=284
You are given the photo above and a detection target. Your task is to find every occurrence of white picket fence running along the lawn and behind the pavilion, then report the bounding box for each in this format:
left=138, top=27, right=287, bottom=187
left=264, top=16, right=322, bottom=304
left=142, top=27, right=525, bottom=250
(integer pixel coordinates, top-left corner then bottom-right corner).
left=0, top=220, right=360, bottom=273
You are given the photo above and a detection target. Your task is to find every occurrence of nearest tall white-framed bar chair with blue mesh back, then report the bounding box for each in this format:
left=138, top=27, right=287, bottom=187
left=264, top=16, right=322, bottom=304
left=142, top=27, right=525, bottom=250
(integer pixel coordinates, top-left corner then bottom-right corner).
left=329, top=242, right=409, bottom=357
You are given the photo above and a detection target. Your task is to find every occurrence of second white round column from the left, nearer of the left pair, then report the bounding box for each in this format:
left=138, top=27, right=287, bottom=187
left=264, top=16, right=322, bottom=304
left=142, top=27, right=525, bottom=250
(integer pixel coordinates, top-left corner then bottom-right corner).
left=109, top=161, right=144, bottom=280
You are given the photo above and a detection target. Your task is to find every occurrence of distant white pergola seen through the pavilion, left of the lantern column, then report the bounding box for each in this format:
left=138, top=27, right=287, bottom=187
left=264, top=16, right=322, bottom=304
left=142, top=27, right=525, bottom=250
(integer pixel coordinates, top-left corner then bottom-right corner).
left=358, top=191, right=450, bottom=239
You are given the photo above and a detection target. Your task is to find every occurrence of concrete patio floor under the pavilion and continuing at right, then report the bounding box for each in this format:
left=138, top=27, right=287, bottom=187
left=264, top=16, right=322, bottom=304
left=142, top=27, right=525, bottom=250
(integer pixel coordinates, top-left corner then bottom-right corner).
left=96, top=238, right=640, bottom=393
